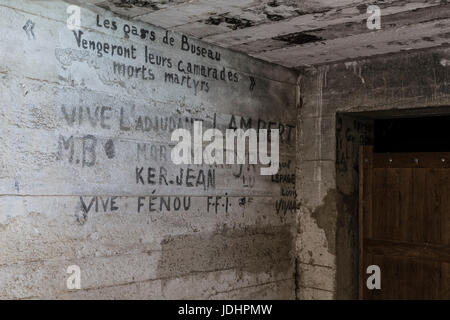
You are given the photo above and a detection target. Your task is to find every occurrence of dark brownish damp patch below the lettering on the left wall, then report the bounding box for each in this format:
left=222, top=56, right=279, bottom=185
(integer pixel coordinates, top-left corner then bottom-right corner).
left=158, top=226, right=294, bottom=278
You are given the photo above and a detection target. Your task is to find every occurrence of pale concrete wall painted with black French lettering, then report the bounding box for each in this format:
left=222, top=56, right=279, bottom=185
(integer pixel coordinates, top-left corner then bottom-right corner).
left=0, top=0, right=298, bottom=299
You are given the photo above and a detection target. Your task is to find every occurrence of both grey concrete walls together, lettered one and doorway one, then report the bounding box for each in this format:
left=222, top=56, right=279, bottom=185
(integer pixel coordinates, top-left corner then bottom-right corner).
left=0, top=0, right=450, bottom=299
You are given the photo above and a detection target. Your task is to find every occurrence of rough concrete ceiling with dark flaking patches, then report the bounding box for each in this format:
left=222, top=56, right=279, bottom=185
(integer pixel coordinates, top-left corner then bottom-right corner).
left=85, top=0, right=450, bottom=68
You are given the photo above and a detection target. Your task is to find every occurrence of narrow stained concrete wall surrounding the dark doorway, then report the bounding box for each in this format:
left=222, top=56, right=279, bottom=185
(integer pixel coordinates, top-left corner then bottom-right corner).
left=297, top=47, right=450, bottom=299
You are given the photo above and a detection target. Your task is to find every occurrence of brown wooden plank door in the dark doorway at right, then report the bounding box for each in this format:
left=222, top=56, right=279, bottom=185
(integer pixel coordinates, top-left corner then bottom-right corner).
left=359, top=146, right=450, bottom=299
